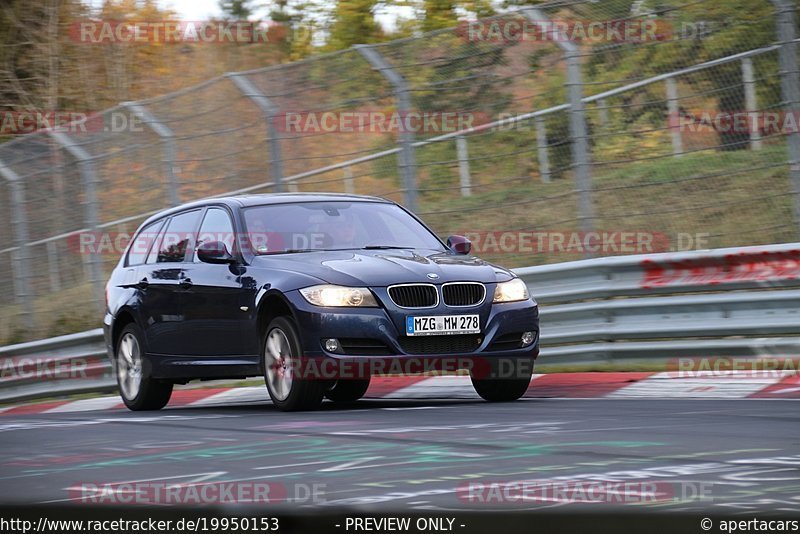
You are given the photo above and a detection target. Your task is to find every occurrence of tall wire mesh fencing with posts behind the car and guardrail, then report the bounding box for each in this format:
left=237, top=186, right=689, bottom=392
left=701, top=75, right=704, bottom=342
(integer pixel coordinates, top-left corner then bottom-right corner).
left=0, top=0, right=800, bottom=343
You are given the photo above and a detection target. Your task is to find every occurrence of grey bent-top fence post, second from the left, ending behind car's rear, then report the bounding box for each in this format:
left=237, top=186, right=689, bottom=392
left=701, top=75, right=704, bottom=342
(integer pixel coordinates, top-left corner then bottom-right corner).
left=48, top=131, right=105, bottom=313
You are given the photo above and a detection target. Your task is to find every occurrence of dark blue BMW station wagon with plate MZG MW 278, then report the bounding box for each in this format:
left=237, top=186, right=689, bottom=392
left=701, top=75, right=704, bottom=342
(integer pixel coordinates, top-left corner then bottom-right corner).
left=104, top=193, right=539, bottom=410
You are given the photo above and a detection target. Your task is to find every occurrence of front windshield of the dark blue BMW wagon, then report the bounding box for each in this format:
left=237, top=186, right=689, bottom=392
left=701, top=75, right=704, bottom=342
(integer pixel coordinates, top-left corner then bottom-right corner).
left=244, top=201, right=445, bottom=254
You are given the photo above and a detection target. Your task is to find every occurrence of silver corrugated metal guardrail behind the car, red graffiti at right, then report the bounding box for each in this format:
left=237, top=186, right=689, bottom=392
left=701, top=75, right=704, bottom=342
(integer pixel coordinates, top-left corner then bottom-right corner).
left=0, top=243, right=800, bottom=401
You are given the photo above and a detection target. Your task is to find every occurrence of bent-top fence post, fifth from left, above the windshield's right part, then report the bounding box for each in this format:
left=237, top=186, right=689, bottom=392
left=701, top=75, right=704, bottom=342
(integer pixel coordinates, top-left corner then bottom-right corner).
left=354, top=45, right=417, bottom=211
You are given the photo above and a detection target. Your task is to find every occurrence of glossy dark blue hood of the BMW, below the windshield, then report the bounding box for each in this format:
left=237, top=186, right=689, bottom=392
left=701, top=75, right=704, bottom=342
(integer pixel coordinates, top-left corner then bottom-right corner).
left=253, top=250, right=513, bottom=287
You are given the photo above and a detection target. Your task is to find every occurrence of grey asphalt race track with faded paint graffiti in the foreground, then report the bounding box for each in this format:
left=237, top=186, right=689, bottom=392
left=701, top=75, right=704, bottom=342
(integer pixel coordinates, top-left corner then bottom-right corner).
left=0, top=399, right=800, bottom=514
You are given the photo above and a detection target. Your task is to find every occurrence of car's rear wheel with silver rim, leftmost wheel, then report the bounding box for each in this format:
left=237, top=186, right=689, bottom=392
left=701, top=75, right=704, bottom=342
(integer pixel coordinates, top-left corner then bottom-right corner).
left=114, top=323, right=172, bottom=412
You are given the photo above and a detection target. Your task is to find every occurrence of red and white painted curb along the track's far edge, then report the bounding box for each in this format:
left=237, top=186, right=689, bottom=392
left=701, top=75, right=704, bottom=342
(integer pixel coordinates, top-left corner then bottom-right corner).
left=0, top=372, right=800, bottom=415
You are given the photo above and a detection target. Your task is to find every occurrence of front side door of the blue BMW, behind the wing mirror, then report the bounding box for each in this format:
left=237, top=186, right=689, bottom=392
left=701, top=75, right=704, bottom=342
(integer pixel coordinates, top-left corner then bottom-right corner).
left=182, top=206, right=249, bottom=356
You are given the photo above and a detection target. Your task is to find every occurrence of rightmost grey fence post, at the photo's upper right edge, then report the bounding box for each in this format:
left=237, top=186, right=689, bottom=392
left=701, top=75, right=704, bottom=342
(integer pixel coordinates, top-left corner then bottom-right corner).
left=772, top=0, right=800, bottom=236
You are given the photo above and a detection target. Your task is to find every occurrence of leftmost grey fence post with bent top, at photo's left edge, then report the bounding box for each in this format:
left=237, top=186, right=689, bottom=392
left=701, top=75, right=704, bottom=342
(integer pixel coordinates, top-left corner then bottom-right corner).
left=0, top=161, right=35, bottom=329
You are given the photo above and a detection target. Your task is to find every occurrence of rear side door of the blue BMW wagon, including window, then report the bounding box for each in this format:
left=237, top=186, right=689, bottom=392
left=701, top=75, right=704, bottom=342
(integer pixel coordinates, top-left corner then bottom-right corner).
left=138, top=209, right=202, bottom=355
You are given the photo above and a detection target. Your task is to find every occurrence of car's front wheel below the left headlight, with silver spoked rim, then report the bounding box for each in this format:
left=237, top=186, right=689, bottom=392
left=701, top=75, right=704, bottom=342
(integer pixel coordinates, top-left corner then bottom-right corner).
left=263, top=317, right=327, bottom=412
